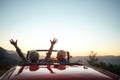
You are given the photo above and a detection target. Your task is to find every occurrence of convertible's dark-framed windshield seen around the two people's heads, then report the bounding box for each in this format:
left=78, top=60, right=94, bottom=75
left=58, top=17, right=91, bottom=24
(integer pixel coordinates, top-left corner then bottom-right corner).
left=20, top=50, right=81, bottom=65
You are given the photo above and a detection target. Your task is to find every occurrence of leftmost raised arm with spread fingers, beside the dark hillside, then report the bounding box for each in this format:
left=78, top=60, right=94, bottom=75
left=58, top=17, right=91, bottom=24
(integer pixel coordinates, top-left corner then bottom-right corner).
left=10, top=39, right=27, bottom=62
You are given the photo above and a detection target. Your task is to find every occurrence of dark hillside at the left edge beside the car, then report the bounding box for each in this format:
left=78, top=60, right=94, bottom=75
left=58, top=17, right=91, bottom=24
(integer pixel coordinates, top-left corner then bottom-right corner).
left=0, top=47, right=19, bottom=76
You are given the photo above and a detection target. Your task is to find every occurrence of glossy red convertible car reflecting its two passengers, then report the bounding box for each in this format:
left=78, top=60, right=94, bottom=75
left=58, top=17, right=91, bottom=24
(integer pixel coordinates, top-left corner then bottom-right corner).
left=0, top=50, right=120, bottom=80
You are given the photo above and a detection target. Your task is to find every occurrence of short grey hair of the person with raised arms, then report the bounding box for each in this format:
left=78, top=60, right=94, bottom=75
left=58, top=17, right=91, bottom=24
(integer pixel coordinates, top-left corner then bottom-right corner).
left=29, top=51, right=39, bottom=63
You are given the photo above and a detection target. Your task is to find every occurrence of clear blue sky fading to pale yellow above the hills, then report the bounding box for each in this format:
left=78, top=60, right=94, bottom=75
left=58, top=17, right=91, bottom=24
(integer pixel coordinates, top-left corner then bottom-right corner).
left=0, top=0, right=120, bottom=56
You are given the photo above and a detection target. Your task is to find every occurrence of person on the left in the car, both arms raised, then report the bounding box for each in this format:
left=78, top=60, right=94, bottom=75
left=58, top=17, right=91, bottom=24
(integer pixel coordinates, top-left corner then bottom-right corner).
left=10, top=38, right=57, bottom=63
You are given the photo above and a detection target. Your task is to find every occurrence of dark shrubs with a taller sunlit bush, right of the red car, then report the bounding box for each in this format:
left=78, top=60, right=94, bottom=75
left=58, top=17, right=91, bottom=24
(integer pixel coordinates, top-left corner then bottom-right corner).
left=87, top=51, right=120, bottom=75
